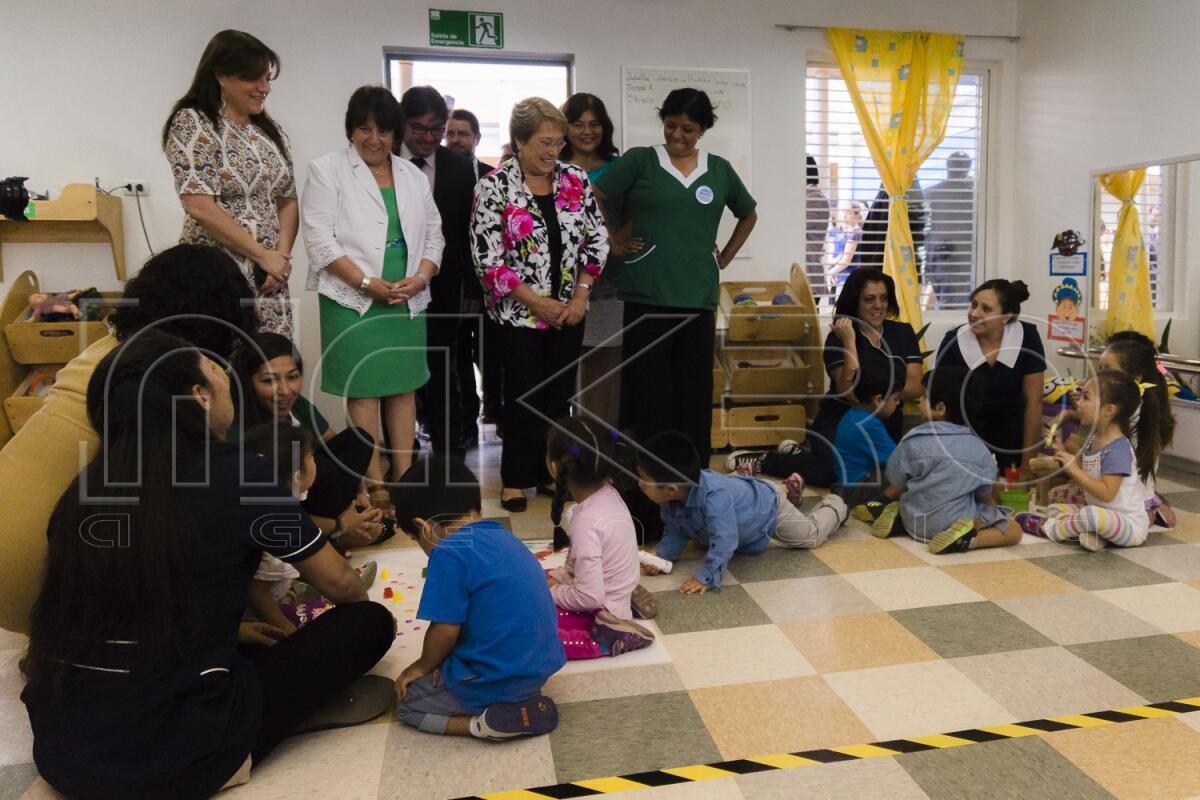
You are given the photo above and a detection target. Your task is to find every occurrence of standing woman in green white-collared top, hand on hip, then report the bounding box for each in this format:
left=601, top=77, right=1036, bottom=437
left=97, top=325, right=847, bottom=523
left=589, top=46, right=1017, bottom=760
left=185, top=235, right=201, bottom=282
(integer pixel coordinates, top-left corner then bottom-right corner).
left=595, top=89, right=758, bottom=464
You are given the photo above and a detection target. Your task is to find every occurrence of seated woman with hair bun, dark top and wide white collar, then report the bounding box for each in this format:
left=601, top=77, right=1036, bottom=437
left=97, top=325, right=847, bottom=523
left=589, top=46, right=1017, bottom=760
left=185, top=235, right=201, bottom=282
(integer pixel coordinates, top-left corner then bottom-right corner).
left=934, top=278, right=1046, bottom=469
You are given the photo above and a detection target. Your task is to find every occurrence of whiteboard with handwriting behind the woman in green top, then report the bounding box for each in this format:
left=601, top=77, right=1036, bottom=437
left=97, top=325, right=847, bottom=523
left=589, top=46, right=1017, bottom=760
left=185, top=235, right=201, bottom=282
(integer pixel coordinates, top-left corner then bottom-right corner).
left=620, top=67, right=754, bottom=258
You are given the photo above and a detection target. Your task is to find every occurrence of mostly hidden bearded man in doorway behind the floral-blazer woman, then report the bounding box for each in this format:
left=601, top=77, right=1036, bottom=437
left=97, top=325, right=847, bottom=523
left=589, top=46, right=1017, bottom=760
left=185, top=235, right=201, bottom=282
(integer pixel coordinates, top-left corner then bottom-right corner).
left=445, top=108, right=503, bottom=450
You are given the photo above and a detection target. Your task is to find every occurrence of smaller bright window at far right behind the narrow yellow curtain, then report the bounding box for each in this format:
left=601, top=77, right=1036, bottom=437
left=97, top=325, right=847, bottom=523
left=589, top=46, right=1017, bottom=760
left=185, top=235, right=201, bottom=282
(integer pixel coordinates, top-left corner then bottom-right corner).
left=1088, top=164, right=1175, bottom=311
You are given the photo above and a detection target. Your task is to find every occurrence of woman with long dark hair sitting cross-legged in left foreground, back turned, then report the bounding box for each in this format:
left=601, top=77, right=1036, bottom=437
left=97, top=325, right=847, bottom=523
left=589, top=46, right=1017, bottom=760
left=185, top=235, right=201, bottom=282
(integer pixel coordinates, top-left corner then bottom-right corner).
left=20, top=330, right=395, bottom=799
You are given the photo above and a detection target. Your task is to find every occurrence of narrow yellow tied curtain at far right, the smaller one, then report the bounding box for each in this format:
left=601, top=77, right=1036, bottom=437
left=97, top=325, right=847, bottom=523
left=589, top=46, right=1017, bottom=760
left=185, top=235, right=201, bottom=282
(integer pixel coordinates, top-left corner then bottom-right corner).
left=1100, top=168, right=1156, bottom=342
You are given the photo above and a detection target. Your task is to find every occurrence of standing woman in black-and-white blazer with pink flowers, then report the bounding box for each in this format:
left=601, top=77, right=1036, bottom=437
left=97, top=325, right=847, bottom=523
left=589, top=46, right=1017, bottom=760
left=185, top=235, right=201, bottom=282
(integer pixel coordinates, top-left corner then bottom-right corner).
left=470, top=97, right=608, bottom=511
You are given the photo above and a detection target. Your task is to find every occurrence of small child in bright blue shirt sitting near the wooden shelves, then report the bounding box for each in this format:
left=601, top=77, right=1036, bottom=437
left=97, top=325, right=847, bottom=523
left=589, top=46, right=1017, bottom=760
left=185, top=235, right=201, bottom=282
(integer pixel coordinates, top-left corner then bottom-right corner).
left=833, top=359, right=905, bottom=506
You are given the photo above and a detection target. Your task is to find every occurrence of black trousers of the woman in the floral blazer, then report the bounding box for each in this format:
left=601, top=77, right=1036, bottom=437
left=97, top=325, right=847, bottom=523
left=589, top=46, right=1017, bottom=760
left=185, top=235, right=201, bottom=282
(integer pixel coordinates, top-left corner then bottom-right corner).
left=497, top=325, right=585, bottom=488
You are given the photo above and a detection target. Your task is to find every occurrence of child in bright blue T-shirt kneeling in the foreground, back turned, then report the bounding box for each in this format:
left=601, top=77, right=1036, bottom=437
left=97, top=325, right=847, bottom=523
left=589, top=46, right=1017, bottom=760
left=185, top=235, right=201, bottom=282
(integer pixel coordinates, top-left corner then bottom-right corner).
left=392, top=456, right=566, bottom=740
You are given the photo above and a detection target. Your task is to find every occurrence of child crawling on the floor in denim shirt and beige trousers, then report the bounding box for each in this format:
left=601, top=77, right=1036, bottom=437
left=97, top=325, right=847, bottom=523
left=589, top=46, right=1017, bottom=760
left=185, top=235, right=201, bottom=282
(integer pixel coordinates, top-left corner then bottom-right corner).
left=637, top=431, right=847, bottom=595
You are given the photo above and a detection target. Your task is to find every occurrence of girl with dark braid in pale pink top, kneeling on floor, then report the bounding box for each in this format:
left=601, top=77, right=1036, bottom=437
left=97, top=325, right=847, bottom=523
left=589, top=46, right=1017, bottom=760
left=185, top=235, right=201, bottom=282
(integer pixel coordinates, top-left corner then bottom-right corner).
left=546, top=416, right=654, bottom=660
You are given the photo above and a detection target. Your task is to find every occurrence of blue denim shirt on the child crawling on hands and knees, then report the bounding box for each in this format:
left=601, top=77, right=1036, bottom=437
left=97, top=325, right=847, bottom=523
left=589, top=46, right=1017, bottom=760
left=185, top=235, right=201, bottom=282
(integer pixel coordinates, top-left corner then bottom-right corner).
left=655, top=469, right=779, bottom=589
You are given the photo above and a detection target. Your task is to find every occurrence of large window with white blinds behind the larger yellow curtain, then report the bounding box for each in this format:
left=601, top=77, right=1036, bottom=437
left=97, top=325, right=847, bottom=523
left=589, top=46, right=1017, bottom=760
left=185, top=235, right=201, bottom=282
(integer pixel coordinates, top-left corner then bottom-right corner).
left=804, top=64, right=988, bottom=311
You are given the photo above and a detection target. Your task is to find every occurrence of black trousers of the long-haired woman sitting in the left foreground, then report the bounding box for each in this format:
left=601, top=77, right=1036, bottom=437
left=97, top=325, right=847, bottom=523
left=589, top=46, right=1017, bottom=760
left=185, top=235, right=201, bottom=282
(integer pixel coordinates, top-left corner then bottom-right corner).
left=240, top=602, right=396, bottom=766
